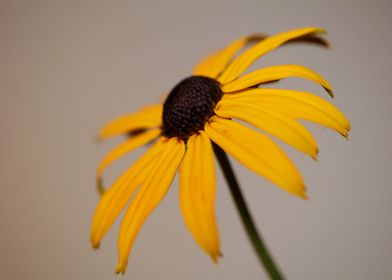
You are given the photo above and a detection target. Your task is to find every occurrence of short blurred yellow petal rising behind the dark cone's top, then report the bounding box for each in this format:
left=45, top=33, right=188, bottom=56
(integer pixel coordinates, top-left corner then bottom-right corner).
left=192, top=35, right=264, bottom=79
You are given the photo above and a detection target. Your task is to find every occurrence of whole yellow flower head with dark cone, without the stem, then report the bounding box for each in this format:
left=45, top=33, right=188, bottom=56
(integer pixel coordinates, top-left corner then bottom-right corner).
left=91, top=27, right=350, bottom=273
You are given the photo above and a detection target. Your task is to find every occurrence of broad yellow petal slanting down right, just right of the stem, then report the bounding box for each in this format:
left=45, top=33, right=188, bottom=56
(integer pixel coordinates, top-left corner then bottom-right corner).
left=205, top=116, right=306, bottom=198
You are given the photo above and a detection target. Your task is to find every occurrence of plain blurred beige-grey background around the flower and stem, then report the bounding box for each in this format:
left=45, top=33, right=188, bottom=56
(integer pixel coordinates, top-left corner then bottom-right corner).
left=0, top=0, right=392, bottom=280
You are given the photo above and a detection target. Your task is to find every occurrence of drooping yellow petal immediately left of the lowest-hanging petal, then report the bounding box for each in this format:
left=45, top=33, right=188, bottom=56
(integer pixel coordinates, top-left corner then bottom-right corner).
left=90, top=141, right=163, bottom=248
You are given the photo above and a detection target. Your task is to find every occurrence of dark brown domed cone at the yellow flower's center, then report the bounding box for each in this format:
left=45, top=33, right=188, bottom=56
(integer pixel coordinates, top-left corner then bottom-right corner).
left=162, top=76, right=222, bottom=140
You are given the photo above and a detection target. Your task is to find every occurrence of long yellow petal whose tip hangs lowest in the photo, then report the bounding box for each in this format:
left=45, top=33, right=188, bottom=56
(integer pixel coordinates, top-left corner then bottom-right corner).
left=116, top=138, right=185, bottom=273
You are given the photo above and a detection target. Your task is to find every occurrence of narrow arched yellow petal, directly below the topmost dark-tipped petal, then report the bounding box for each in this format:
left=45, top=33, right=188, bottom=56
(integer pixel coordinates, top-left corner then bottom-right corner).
left=222, top=65, right=333, bottom=97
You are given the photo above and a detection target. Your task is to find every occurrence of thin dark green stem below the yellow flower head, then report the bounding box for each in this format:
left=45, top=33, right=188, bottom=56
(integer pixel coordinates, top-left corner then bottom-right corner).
left=213, top=143, right=284, bottom=280
